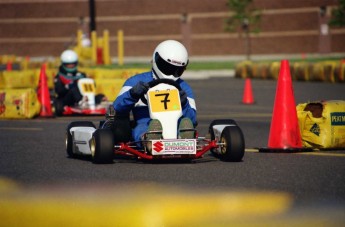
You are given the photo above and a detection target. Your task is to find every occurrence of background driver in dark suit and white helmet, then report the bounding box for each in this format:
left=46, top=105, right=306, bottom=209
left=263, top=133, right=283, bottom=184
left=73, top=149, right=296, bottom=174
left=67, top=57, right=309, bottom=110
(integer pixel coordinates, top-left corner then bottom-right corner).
left=54, top=50, right=86, bottom=106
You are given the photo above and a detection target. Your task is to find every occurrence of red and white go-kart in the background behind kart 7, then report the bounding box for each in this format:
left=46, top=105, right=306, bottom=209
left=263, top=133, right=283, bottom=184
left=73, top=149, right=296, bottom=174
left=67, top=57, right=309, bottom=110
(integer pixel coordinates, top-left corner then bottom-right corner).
left=54, top=78, right=110, bottom=116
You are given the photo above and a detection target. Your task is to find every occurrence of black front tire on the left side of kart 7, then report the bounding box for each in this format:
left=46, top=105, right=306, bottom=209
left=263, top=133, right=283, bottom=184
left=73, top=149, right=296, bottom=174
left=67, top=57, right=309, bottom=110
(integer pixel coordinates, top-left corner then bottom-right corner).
left=91, top=129, right=114, bottom=164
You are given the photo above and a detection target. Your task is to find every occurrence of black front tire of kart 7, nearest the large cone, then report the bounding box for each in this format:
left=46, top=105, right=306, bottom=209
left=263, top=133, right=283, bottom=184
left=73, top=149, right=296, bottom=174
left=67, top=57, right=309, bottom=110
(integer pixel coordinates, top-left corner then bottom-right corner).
left=220, top=126, right=245, bottom=162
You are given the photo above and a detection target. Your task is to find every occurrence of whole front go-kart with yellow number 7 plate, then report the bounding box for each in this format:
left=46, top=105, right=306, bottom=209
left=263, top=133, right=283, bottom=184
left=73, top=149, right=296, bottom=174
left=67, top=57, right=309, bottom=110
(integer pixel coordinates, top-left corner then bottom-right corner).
left=66, top=79, right=245, bottom=163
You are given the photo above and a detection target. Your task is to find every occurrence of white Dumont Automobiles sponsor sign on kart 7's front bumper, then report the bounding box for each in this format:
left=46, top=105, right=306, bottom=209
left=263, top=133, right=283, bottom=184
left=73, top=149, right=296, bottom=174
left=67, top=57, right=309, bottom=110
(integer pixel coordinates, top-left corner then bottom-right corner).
left=152, top=139, right=196, bottom=155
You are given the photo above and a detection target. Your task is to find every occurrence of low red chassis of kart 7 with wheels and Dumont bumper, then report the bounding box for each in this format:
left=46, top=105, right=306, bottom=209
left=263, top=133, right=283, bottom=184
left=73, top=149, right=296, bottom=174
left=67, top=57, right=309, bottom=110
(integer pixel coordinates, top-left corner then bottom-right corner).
left=66, top=119, right=245, bottom=163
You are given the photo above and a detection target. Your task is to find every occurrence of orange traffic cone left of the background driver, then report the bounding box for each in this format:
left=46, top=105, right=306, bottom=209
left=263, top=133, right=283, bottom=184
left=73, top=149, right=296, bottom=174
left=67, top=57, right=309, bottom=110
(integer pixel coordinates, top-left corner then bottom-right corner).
left=37, top=64, right=53, bottom=117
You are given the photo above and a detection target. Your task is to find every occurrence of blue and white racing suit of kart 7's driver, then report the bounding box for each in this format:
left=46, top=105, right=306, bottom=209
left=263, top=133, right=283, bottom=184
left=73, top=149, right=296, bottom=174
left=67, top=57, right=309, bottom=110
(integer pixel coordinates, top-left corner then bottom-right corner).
left=113, top=71, right=197, bottom=140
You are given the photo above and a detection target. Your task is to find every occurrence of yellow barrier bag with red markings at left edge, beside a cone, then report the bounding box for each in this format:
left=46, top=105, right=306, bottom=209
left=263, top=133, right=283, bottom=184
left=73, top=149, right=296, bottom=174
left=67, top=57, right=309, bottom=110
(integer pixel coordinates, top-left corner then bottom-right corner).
left=0, top=88, right=41, bottom=119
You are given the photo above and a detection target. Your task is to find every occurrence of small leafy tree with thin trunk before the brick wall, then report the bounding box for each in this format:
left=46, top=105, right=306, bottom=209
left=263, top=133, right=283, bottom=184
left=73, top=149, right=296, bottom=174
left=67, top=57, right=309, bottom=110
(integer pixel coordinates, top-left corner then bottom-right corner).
left=225, top=0, right=261, bottom=60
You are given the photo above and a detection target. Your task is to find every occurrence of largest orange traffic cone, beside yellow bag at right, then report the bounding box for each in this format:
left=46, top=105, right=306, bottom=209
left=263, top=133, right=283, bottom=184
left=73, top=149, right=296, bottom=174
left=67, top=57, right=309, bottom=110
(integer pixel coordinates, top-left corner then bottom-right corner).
left=259, top=60, right=311, bottom=152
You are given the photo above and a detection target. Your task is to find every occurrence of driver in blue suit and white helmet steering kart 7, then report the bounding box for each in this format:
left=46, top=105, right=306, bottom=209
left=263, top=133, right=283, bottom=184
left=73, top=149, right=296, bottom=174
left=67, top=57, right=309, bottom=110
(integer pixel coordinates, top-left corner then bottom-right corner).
left=113, top=40, right=197, bottom=141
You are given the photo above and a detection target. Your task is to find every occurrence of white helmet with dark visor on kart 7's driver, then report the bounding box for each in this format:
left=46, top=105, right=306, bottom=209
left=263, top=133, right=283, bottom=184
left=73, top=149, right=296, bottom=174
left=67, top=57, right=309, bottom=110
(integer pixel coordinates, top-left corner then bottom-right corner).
left=152, top=40, right=188, bottom=81
